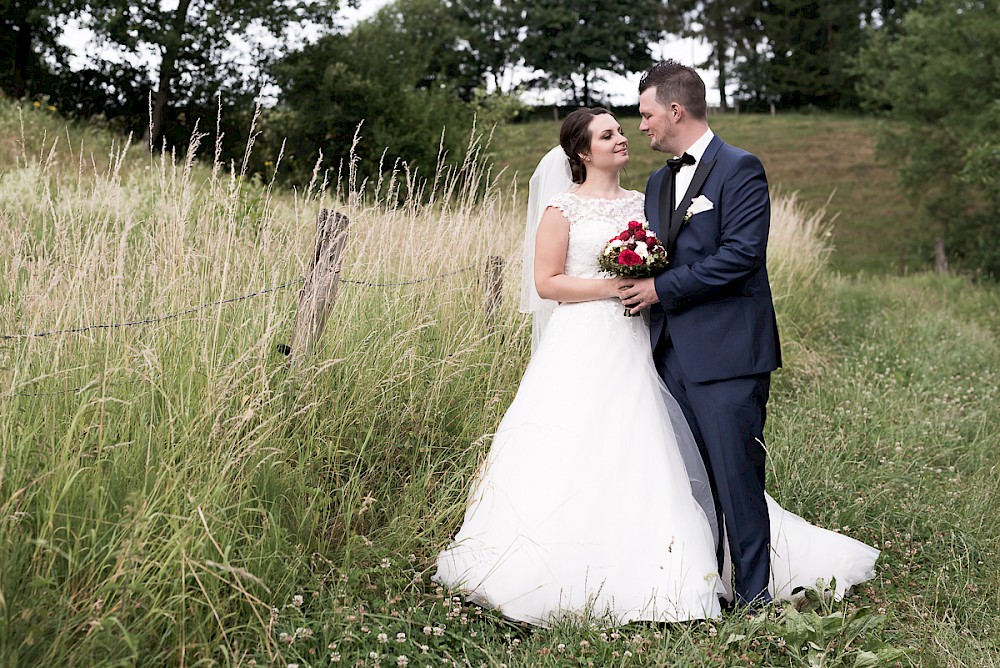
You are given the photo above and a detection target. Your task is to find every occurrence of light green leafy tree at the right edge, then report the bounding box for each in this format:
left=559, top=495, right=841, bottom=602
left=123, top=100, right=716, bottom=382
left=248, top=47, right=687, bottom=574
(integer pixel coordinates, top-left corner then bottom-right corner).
left=857, top=0, right=1000, bottom=276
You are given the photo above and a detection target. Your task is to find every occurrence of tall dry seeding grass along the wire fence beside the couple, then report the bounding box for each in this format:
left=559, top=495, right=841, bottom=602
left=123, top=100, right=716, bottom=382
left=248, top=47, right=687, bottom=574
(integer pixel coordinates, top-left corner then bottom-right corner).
left=0, top=107, right=828, bottom=665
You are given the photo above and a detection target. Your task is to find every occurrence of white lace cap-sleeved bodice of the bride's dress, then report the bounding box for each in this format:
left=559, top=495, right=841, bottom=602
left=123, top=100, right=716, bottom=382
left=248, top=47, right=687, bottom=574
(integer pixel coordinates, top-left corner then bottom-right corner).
left=549, top=190, right=645, bottom=278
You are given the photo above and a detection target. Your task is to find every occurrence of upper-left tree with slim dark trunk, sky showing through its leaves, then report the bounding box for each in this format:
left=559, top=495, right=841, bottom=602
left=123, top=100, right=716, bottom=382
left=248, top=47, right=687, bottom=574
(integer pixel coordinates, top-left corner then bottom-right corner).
left=80, top=0, right=350, bottom=146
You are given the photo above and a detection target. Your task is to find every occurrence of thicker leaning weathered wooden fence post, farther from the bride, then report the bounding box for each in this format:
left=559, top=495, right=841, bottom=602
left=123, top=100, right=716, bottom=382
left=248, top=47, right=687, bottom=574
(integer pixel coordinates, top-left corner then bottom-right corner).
left=291, top=209, right=349, bottom=363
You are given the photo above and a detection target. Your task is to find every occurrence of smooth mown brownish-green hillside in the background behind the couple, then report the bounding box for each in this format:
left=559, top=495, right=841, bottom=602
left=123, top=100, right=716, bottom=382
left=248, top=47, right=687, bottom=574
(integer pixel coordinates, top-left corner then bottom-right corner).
left=492, top=114, right=920, bottom=274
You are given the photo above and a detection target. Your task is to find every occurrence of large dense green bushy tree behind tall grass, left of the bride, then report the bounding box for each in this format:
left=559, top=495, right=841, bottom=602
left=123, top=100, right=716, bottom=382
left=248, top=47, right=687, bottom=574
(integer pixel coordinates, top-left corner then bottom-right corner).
left=265, top=0, right=472, bottom=181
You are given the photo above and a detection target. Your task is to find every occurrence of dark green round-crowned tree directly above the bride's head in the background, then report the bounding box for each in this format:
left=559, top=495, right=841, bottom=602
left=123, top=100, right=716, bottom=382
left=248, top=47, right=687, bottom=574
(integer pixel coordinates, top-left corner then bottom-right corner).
left=521, top=0, right=665, bottom=106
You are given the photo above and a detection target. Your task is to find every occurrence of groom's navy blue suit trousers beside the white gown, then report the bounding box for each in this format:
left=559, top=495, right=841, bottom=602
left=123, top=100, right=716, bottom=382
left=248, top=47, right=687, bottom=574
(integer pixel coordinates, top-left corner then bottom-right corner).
left=653, top=338, right=771, bottom=605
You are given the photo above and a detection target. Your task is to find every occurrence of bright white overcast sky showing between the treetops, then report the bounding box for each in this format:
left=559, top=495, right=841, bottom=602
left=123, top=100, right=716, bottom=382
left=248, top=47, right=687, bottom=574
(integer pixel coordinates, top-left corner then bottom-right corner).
left=60, top=0, right=719, bottom=105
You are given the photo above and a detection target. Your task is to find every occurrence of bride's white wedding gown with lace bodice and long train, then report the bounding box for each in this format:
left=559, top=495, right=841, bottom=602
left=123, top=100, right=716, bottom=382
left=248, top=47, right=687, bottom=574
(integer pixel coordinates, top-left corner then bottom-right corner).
left=434, top=193, right=879, bottom=626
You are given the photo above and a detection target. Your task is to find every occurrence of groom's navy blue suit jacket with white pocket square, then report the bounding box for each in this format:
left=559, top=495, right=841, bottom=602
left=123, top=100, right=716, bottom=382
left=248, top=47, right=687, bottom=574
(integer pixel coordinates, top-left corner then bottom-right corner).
left=645, top=135, right=781, bottom=382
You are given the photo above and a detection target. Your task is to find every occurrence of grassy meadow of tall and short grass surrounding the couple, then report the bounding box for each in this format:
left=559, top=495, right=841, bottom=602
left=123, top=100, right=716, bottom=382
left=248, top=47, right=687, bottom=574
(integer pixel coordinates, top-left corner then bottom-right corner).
left=0, top=103, right=1000, bottom=668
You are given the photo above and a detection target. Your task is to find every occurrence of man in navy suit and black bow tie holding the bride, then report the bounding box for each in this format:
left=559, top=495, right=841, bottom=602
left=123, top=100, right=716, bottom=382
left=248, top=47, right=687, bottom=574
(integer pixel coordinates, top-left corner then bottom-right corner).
left=620, top=60, right=781, bottom=609
